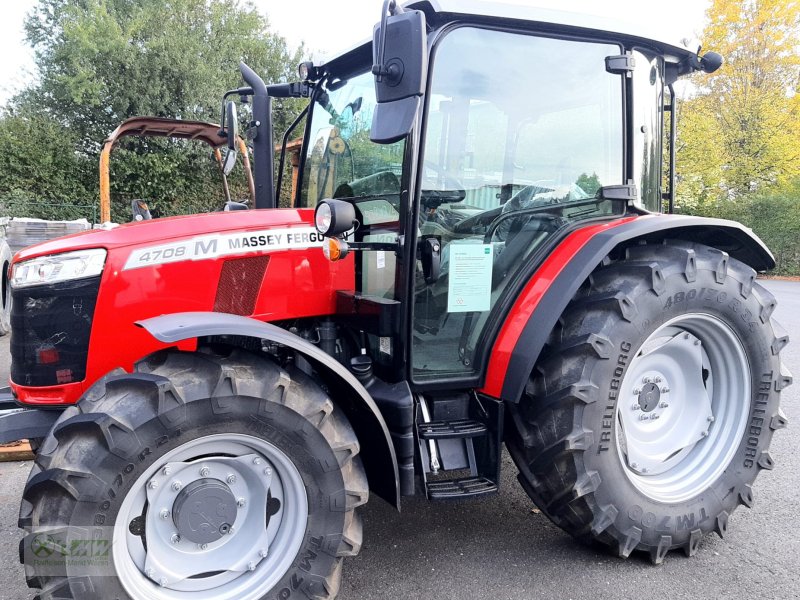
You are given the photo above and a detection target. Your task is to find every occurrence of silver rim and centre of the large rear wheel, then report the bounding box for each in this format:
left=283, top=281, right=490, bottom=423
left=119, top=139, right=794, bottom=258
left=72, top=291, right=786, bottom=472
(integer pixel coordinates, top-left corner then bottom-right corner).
left=616, top=313, right=751, bottom=503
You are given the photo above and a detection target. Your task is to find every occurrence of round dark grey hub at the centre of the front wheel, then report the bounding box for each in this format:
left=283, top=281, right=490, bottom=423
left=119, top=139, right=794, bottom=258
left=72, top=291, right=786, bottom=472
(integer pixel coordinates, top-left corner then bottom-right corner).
left=172, top=478, right=237, bottom=544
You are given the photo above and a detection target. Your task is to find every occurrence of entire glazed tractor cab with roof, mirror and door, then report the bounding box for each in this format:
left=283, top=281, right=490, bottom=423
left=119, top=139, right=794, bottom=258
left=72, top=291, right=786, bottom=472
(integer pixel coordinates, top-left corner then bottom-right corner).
left=282, top=2, right=718, bottom=386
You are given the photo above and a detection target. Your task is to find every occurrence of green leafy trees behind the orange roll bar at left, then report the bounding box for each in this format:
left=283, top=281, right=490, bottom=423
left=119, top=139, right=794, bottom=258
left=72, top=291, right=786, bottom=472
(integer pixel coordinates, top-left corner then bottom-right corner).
left=0, top=0, right=302, bottom=221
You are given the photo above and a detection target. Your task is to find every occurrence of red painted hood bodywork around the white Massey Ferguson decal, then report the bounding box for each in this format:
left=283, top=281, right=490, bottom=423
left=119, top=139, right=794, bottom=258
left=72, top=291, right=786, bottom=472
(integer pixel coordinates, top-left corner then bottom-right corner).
left=11, top=209, right=355, bottom=404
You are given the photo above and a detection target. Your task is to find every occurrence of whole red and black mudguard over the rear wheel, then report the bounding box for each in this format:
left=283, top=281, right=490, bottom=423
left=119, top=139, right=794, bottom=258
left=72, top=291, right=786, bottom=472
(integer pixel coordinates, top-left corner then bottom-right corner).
left=480, top=215, right=775, bottom=402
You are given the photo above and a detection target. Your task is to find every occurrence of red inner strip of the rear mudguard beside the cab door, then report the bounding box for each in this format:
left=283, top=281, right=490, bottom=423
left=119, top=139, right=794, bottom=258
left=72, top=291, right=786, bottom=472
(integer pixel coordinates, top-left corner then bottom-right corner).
left=479, top=217, right=636, bottom=398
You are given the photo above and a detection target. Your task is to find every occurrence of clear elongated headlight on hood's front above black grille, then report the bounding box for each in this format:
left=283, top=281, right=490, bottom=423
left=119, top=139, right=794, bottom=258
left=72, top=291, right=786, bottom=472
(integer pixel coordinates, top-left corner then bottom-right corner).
left=9, top=248, right=106, bottom=288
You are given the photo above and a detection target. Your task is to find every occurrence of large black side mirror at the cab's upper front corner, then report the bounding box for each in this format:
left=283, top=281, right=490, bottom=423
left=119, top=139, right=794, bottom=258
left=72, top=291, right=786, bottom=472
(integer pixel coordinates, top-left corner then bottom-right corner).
left=370, top=0, right=428, bottom=144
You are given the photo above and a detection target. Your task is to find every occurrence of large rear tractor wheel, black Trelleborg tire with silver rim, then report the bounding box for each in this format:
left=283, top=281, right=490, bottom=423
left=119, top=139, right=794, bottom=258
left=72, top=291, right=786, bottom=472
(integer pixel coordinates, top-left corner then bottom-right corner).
left=507, top=242, right=791, bottom=563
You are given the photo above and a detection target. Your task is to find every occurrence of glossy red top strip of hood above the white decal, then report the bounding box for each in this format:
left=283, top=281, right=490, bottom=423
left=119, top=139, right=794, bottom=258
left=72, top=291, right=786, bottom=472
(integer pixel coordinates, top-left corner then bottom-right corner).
left=15, top=209, right=314, bottom=262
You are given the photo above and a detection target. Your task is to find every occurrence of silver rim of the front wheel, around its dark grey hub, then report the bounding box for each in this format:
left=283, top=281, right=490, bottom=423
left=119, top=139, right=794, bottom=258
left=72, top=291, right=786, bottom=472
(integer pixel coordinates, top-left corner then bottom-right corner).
left=113, top=434, right=308, bottom=600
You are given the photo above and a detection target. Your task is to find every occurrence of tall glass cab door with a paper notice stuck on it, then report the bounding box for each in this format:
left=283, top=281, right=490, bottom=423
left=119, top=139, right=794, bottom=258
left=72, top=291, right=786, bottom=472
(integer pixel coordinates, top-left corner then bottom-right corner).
left=411, top=26, right=624, bottom=387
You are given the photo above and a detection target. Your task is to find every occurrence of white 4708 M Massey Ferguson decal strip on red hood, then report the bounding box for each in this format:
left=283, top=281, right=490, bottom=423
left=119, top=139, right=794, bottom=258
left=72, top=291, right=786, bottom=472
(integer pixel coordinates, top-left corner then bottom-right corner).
left=122, top=227, right=322, bottom=271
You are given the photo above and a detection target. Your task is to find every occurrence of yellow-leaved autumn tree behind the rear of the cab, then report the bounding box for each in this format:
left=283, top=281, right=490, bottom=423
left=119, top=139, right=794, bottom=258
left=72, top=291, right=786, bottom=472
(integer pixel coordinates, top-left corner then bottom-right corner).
left=677, top=0, right=800, bottom=210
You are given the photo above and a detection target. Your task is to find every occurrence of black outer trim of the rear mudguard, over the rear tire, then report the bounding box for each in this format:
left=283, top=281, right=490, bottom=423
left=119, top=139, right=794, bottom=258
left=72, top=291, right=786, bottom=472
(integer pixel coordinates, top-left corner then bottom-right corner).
left=500, top=215, right=775, bottom=402
